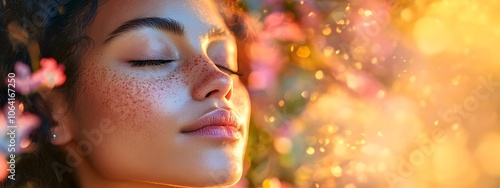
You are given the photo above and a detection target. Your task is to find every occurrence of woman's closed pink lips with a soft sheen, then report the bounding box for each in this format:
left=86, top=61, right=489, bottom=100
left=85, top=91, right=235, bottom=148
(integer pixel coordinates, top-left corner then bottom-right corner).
left=181, top=109, right=242, bottom=141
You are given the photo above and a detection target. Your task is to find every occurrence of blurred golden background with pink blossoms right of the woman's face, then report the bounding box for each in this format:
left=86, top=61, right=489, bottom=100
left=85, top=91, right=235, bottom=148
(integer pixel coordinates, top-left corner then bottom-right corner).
left=236, top=0, right=500, bottom=188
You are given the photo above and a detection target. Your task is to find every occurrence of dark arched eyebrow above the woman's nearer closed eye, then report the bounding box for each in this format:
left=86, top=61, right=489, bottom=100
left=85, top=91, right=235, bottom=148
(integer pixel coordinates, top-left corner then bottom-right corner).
left=103, top=17, right=184, bottom=44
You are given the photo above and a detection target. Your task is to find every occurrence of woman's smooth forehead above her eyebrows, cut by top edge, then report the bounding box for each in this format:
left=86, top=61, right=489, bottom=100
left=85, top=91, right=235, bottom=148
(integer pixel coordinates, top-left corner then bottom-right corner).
left=87, top=0, right=224, bottom=43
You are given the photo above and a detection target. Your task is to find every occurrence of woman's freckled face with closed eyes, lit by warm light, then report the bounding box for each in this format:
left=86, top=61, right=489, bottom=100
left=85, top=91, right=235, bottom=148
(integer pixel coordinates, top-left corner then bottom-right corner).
left=62, top=0, right=250, bottom=186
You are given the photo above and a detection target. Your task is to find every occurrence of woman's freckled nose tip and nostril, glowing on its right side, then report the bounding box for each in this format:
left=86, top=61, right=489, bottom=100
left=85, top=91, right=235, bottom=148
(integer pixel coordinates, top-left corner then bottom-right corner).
left=191, top=58, right=233, bottom=101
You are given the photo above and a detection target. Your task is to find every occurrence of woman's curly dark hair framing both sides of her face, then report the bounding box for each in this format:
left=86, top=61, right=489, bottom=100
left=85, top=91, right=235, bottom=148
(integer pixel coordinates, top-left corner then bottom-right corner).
left=0, top=0, right=251, bottom=188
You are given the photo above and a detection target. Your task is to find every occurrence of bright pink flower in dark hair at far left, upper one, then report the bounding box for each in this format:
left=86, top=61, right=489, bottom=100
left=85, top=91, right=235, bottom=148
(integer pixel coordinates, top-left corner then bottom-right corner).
left=14, top=58, right=66, bottom=94
